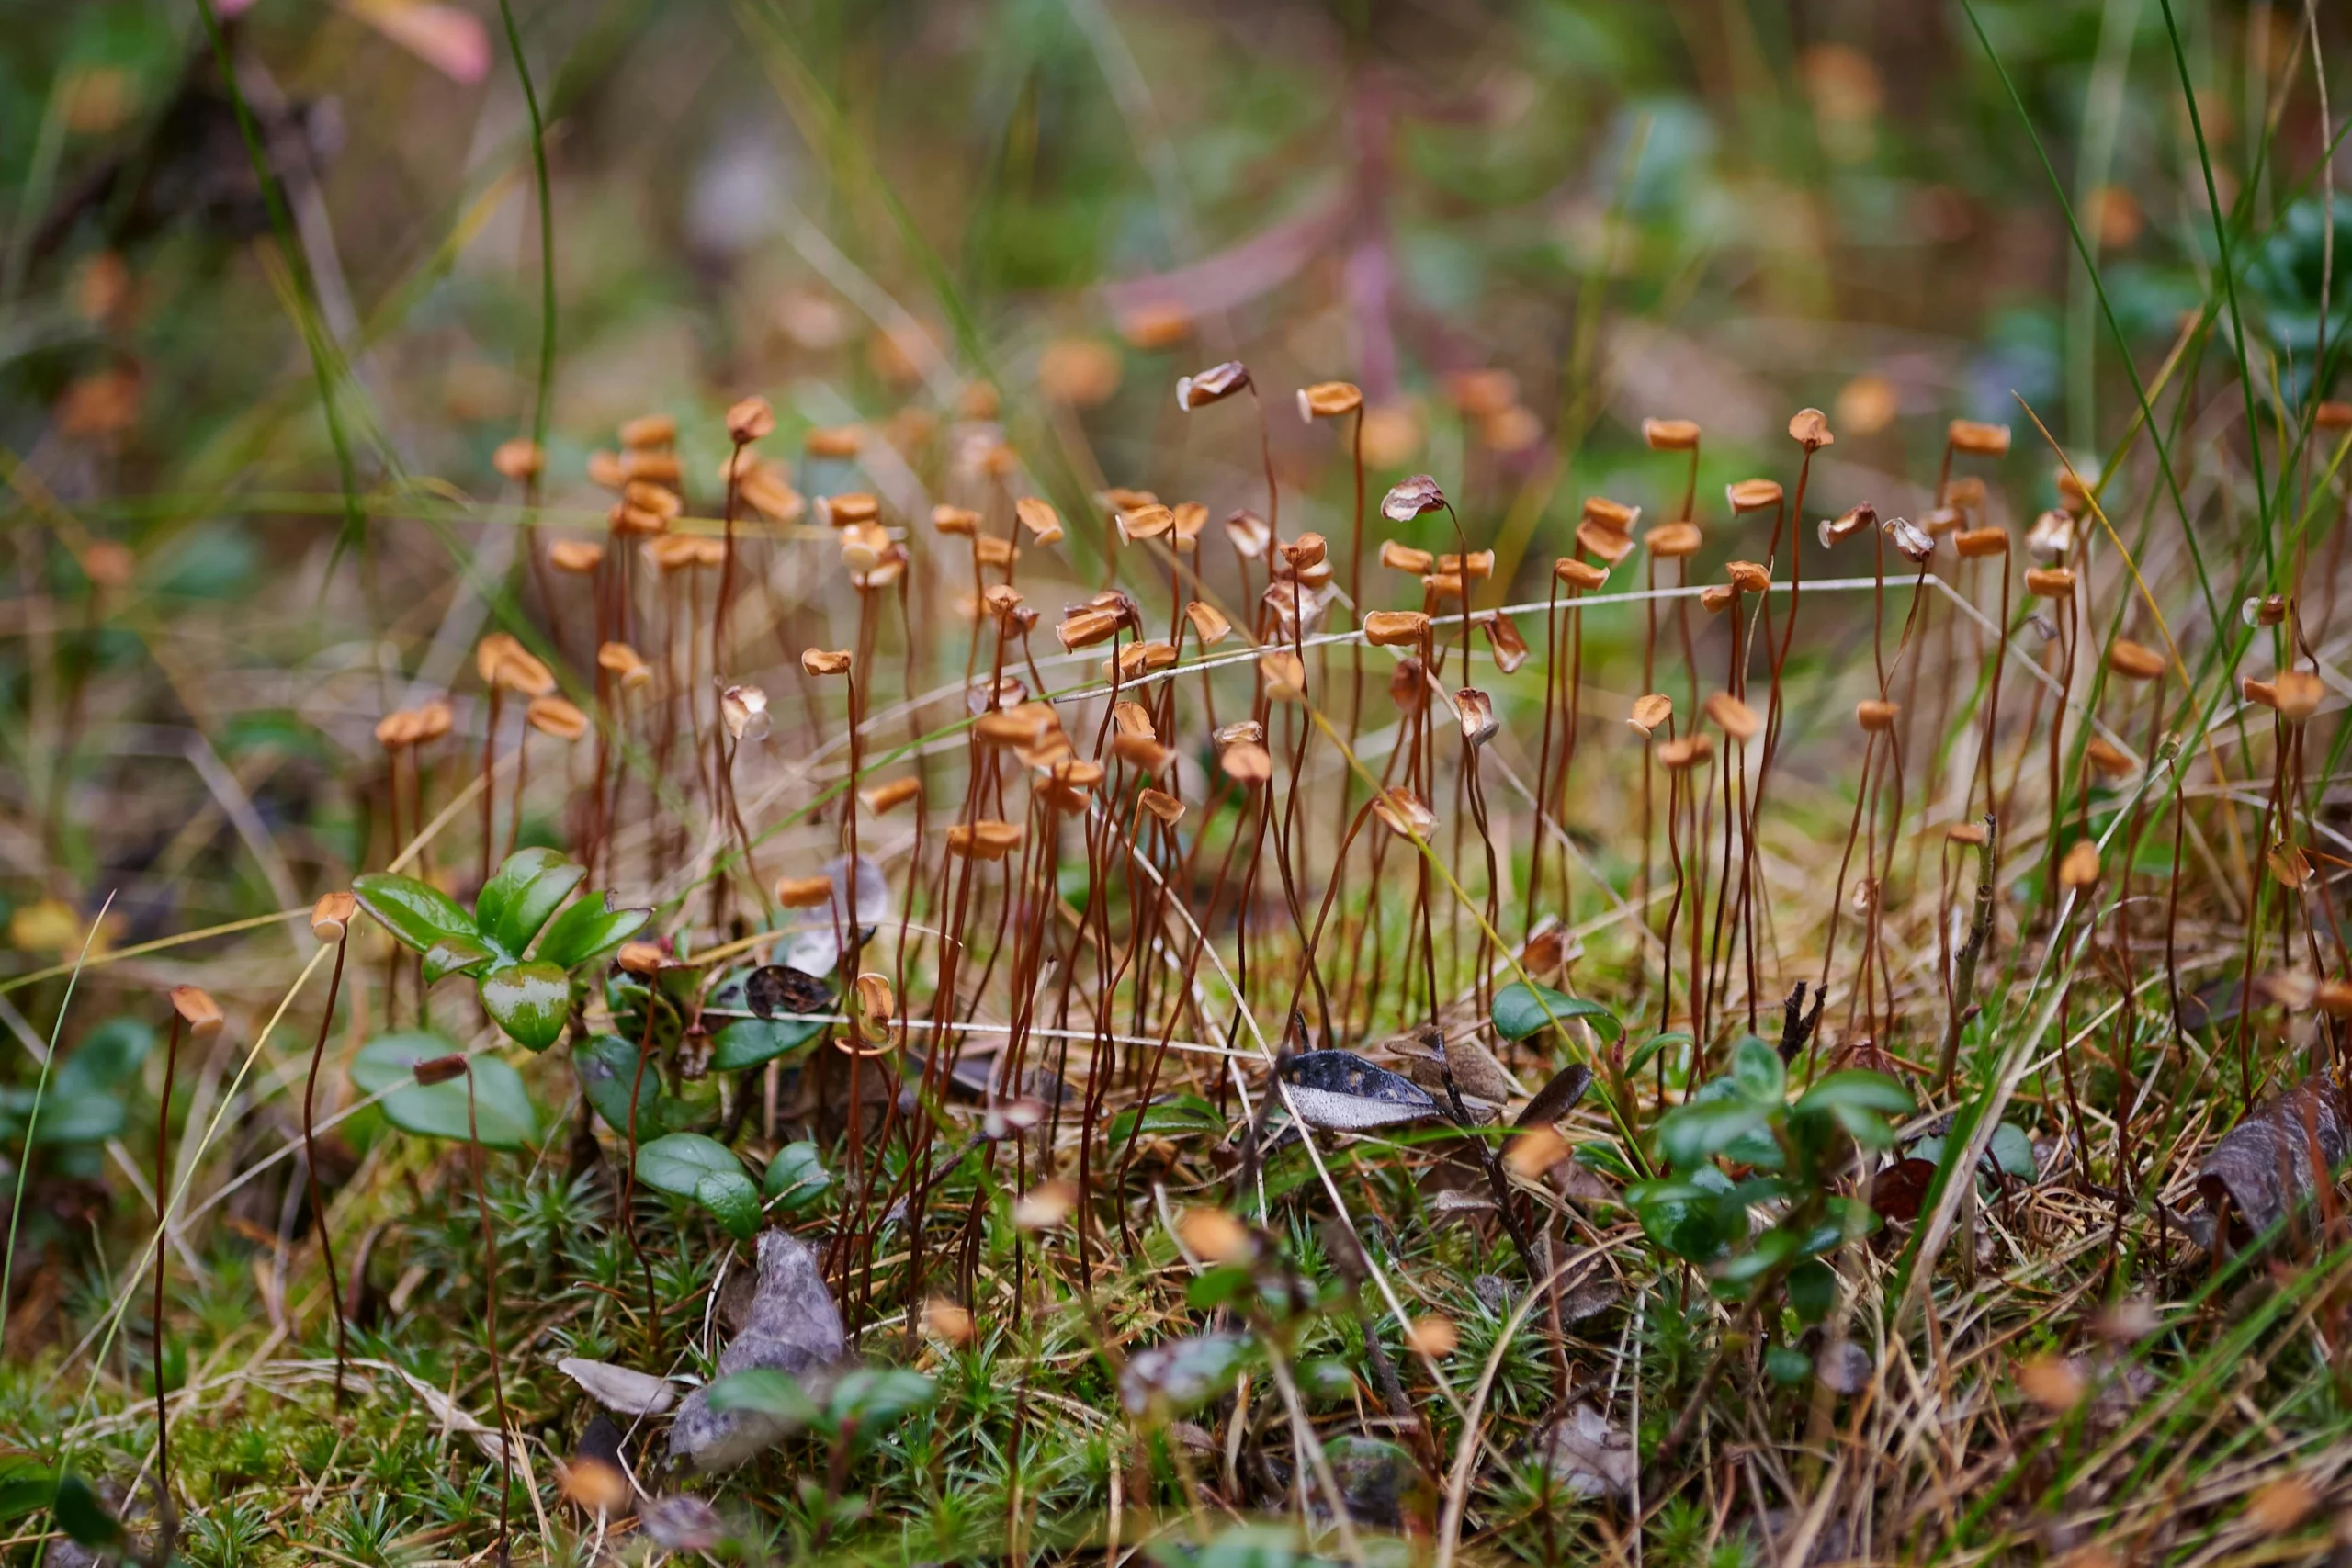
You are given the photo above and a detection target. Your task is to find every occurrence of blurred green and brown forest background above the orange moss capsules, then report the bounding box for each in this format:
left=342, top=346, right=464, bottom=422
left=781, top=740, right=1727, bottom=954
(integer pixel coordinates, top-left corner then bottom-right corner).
left=0, top=0, right=2352, bottom=931
